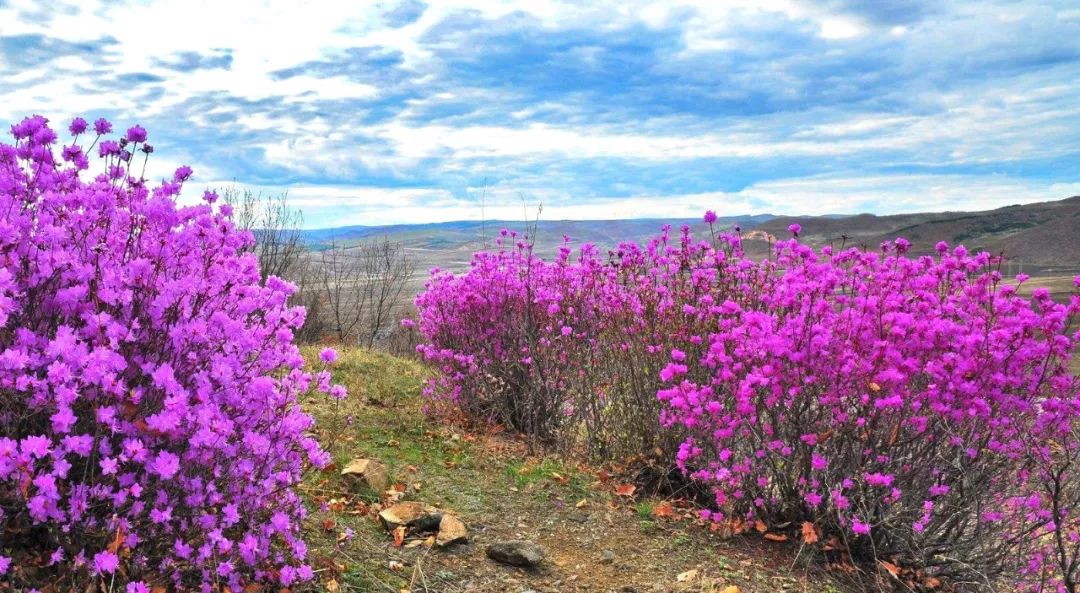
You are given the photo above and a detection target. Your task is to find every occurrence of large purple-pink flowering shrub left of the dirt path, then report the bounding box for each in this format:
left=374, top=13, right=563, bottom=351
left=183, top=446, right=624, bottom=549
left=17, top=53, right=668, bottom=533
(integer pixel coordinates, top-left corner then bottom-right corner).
left=0, top=116, right=345, bottom=591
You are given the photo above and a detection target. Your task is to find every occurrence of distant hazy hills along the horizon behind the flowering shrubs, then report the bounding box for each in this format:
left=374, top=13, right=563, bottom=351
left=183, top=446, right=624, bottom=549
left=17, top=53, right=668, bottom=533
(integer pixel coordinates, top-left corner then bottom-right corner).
left=303, top=196, right=1080, bottom=273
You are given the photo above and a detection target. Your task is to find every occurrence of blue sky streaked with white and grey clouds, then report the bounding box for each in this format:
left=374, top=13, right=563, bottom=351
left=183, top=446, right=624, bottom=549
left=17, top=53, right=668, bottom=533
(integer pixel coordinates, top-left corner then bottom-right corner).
left=0, top=0, right=1080, bottom=228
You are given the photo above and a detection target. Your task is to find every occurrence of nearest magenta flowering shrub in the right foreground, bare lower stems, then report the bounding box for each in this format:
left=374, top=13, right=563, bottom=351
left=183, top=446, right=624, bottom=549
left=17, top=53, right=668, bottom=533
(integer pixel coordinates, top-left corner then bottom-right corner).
left=658, top=235, right=1080, bottom=591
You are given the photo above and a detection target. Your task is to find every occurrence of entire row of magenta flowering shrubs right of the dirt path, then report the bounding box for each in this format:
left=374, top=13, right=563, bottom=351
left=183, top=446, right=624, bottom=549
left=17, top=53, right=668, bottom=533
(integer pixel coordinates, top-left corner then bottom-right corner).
left=417, top=213, right=1080, bottom=587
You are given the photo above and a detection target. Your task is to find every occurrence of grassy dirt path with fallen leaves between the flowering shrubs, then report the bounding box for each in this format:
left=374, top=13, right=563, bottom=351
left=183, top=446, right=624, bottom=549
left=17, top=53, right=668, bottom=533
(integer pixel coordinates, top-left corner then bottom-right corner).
left=302, top=349, right=852, bottom=593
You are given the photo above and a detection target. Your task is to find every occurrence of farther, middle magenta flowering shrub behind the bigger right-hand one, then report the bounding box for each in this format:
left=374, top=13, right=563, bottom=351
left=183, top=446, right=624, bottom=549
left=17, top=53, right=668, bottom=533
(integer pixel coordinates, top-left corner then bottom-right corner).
left=416, top=223, right=751, bottom=461
